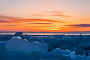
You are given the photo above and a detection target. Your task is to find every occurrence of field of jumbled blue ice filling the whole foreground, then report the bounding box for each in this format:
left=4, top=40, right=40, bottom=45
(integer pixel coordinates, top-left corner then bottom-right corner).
left=0, top=35, right=90, bottom=60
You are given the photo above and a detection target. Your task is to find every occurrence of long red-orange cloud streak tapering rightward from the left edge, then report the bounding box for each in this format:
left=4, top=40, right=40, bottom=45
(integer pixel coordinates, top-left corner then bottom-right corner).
left=0, top=16, right=64, bottom=23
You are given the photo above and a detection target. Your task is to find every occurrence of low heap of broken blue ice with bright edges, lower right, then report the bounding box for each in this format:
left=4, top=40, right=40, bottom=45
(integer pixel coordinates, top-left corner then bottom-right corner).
left=49, top=48, right=83, bottom=60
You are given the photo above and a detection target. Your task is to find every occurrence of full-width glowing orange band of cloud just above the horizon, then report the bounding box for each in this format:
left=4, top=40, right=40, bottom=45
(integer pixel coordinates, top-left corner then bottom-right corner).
left=0, top=16, right=90, bottom=32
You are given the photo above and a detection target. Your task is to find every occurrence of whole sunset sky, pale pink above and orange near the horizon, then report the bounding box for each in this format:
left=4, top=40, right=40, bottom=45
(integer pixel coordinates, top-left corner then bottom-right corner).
left=0, top=0, right=90, bottom=32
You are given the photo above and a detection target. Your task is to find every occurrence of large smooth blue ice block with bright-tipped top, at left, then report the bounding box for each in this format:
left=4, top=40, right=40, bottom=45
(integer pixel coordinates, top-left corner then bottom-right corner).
left=6, top=37, right=48, bottom=60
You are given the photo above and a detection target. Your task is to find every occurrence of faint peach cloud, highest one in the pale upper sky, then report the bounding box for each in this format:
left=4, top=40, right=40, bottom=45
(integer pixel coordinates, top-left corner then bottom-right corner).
left=31, top=11, right=71, bottom=17
